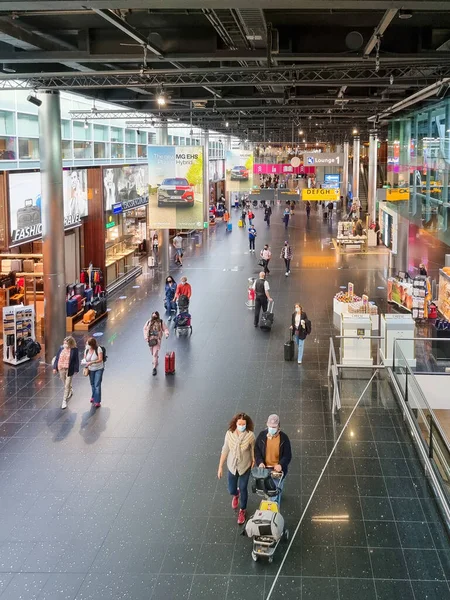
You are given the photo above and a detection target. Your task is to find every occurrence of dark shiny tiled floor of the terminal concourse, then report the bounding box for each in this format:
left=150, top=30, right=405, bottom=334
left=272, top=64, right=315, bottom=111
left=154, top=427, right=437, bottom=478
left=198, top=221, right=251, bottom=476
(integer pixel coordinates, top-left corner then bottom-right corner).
left=0, top=207, right=450, bottom=600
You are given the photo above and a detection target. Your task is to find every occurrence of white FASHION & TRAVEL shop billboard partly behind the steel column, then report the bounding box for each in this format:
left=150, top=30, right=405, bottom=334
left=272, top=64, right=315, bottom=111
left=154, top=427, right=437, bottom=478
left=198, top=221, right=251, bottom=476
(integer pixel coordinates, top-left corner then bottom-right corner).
left=8, top=169, right=88, bottom=247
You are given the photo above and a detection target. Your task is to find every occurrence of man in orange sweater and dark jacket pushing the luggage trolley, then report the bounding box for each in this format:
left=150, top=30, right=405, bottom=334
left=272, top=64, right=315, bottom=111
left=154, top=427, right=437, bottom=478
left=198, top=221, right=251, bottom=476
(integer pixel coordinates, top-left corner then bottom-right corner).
left=255, top=414, right=292, bottom=502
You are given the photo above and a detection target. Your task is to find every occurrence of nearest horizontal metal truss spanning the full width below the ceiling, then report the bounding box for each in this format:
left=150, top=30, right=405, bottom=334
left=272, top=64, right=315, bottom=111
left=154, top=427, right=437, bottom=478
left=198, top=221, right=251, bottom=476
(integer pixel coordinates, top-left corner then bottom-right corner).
left=0, top=65, right=450, bottom=90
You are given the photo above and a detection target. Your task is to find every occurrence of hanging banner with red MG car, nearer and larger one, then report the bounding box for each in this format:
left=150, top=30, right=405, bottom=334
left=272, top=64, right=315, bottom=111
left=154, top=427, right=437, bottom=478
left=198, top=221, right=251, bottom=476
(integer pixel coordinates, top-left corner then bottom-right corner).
left=147, top=146, right=203, bottom=229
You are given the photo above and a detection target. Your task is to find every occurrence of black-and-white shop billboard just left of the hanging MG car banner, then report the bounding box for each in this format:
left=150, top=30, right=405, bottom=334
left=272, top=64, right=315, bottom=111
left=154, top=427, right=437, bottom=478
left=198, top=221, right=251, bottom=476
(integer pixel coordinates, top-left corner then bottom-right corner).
left=103, top=165, right=148, bottom=212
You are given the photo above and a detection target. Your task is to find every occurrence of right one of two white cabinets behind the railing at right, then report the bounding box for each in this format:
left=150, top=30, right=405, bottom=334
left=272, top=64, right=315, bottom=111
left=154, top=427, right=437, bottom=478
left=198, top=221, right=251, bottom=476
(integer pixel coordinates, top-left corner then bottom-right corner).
left=380, top=314, right=416, bottom=367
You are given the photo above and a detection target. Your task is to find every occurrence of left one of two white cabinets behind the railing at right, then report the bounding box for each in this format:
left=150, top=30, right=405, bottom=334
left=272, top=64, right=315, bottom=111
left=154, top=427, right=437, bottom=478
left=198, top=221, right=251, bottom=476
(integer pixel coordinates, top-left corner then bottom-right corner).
left=340, top=314, right=373, bottom=367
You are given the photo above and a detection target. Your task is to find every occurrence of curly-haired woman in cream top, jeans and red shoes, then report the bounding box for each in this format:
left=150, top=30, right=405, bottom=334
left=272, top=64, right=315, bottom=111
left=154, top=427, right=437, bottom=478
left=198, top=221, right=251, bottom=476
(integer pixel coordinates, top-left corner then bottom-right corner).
left=217, top=413, right=255, bottom=525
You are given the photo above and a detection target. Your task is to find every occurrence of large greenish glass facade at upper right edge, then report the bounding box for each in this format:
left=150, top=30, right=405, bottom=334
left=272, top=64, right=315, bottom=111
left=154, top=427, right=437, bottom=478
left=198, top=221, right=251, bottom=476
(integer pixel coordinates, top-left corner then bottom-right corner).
left=386, top=100, right=450, bottom=244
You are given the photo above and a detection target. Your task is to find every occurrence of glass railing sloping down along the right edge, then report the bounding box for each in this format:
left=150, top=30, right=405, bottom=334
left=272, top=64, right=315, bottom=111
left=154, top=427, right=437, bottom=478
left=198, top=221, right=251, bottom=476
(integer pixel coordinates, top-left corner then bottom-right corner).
left=392, top=338, right=450, bottom=510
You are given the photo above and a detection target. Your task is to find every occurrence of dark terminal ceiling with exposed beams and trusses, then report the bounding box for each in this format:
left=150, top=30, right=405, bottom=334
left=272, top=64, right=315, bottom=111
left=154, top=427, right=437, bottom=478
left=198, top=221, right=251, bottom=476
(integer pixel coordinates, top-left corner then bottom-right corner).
left=0, top=0, right=450, bottom=141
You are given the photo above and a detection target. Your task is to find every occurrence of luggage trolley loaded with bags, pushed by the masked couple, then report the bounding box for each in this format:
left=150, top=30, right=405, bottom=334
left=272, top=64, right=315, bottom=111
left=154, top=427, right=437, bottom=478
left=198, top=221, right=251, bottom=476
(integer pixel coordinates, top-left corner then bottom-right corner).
left=245, top=467, right=289, bottom=563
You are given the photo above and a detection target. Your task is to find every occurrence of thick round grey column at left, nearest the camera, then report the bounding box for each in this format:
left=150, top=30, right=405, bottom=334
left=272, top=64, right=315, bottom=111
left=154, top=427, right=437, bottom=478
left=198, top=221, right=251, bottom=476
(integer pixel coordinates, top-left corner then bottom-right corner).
left=39, top=91, right=66, bottom=362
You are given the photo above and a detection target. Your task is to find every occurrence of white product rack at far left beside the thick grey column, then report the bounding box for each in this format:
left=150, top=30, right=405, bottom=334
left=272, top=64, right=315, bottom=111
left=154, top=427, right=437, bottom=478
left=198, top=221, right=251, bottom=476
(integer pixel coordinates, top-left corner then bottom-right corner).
left=3, top=304, right=36, bottom=365
